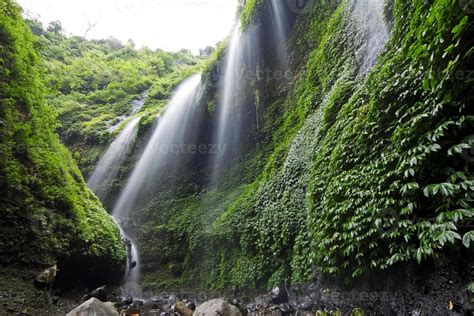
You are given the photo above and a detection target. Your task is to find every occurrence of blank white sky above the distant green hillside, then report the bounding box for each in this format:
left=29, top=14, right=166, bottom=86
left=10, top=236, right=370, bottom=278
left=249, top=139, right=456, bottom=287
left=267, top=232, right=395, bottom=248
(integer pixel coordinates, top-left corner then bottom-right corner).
left=17, top=0, right=237, bottom=53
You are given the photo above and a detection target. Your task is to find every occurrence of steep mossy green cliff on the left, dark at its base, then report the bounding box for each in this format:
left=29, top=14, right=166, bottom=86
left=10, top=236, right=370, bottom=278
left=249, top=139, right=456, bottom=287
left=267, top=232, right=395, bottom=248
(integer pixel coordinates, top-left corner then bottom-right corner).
left=0, top=0, right=125, bottom=284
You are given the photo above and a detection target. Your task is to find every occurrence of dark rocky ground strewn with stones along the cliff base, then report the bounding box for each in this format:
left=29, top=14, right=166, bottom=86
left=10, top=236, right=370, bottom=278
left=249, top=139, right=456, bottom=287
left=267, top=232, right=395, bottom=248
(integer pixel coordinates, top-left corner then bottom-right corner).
left=0, top=254, right=474, bottom=316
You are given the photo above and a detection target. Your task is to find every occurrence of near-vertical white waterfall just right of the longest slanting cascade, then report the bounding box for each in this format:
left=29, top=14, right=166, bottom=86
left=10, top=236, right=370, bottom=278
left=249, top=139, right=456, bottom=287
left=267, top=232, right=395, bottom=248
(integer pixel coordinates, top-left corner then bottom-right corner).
left=212, top=23, right=245, bottom=184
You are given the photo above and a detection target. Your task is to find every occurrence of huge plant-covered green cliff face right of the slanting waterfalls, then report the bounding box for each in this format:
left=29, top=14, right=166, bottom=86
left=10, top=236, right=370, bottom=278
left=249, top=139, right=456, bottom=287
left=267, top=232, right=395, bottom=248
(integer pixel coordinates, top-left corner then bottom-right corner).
left=136, top=0, right=474, bottom=289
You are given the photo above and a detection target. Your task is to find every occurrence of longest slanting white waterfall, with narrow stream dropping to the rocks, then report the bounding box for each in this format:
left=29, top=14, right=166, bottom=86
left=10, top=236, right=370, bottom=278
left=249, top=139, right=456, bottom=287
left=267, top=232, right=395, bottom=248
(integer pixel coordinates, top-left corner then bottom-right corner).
left=112, top=75, right=201, bottom=296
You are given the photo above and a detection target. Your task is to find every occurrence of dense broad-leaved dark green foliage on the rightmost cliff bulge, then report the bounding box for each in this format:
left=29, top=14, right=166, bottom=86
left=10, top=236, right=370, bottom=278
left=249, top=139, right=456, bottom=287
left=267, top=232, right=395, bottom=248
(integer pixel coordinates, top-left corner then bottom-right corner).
left=308, top=1, right=474, bottom=277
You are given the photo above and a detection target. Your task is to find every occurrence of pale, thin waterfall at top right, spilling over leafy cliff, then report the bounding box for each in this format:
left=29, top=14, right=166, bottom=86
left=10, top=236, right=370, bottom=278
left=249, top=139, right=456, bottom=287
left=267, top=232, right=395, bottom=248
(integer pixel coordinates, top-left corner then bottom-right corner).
left=354, top=0, right=388, bottom=75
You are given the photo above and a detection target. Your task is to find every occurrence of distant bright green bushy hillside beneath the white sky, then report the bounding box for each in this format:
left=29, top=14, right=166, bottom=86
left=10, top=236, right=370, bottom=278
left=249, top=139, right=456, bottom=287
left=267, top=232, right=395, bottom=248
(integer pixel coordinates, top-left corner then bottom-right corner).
left=29, top=20, right=202, bottom=174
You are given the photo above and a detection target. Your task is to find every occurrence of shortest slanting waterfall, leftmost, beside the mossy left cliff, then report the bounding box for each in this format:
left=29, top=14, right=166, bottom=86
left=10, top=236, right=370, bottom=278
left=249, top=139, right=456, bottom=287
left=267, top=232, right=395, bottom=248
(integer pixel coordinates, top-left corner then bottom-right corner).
left=87, top=118, right=140, bottom=200
